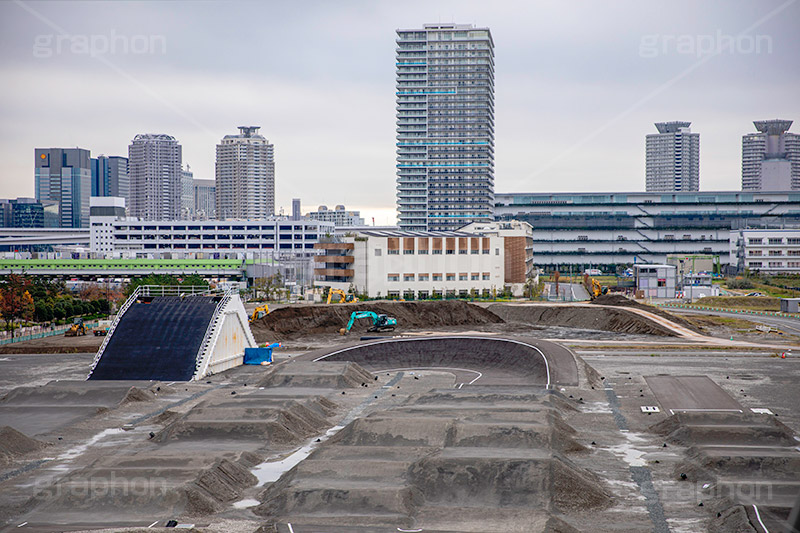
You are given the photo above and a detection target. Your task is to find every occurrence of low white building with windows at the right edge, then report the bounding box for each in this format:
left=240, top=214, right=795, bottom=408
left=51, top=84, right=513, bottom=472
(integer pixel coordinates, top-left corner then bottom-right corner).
left=730, top=227, right=800, bottom=274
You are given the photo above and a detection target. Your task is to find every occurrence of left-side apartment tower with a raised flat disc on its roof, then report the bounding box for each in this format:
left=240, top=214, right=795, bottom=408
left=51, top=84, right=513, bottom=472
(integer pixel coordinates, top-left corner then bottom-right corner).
left=216, top=126, right=275, bottom=220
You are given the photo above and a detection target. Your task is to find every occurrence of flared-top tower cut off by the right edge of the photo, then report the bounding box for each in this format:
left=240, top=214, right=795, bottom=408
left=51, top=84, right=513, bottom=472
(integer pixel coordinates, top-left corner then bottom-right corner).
left=742, top=119, right=800, bottom=191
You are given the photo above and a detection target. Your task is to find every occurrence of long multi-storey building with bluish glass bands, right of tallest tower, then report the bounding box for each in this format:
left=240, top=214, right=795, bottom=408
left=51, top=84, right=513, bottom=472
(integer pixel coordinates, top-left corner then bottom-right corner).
left=495, top=191, right=800, bottom=269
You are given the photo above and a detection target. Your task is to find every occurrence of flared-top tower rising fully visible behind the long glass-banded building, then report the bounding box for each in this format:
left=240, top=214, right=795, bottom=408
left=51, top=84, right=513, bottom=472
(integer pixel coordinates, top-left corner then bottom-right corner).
left=645, top=122, right=700, bottom=192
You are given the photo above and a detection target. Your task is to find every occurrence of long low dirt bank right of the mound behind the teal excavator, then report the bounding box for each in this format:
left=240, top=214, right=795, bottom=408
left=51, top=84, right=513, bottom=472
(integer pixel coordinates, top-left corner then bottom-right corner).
left=488, top=304, right=675, bottom=337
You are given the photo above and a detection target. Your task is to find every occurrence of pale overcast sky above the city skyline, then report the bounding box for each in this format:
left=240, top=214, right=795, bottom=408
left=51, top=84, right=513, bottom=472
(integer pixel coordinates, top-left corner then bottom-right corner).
left=0, top=0, right=800, bottom=224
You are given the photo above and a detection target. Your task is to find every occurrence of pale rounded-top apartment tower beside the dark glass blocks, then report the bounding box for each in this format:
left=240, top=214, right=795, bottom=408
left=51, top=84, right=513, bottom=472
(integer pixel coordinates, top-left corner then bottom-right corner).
left=128, top=133, right=182, bottom=220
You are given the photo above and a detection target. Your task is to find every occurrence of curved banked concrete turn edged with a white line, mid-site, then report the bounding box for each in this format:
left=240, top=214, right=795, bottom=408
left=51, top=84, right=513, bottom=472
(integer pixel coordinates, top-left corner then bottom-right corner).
left=314, top=335, right=551, bottom=386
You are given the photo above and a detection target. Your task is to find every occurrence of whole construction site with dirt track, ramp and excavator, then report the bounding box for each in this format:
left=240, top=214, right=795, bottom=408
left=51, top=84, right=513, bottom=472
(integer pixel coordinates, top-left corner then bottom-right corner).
left=0, top=286, right=800, bottom=533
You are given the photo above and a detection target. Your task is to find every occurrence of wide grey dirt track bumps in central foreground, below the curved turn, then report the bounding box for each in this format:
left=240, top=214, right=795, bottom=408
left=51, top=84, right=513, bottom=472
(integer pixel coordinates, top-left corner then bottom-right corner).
left=254, top=387, right=613, bottom=532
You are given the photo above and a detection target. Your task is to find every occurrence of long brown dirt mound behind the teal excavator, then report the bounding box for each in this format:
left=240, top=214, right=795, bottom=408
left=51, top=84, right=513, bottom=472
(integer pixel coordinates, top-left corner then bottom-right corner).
left=250, top=300, right=503, bottom=343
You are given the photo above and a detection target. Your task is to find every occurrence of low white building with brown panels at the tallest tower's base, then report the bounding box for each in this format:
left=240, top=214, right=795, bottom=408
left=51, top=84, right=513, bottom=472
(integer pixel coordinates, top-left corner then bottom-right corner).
left=314, top=222, right=535, bottom=300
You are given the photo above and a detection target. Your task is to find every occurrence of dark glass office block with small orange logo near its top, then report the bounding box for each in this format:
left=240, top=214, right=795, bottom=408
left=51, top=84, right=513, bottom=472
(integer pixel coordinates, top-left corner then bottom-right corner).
left=34, top=148, right=92, bottom=228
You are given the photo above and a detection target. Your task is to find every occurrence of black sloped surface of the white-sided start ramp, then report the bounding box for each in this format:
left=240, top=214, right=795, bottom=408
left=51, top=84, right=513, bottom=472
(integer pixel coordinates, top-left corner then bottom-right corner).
left=89, top=296, right=217, bottom=381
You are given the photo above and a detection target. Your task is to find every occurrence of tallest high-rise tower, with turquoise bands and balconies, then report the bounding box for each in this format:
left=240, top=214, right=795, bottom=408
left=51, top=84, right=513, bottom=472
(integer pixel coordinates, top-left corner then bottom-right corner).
left=396, top=24, right=494, bottom=230
